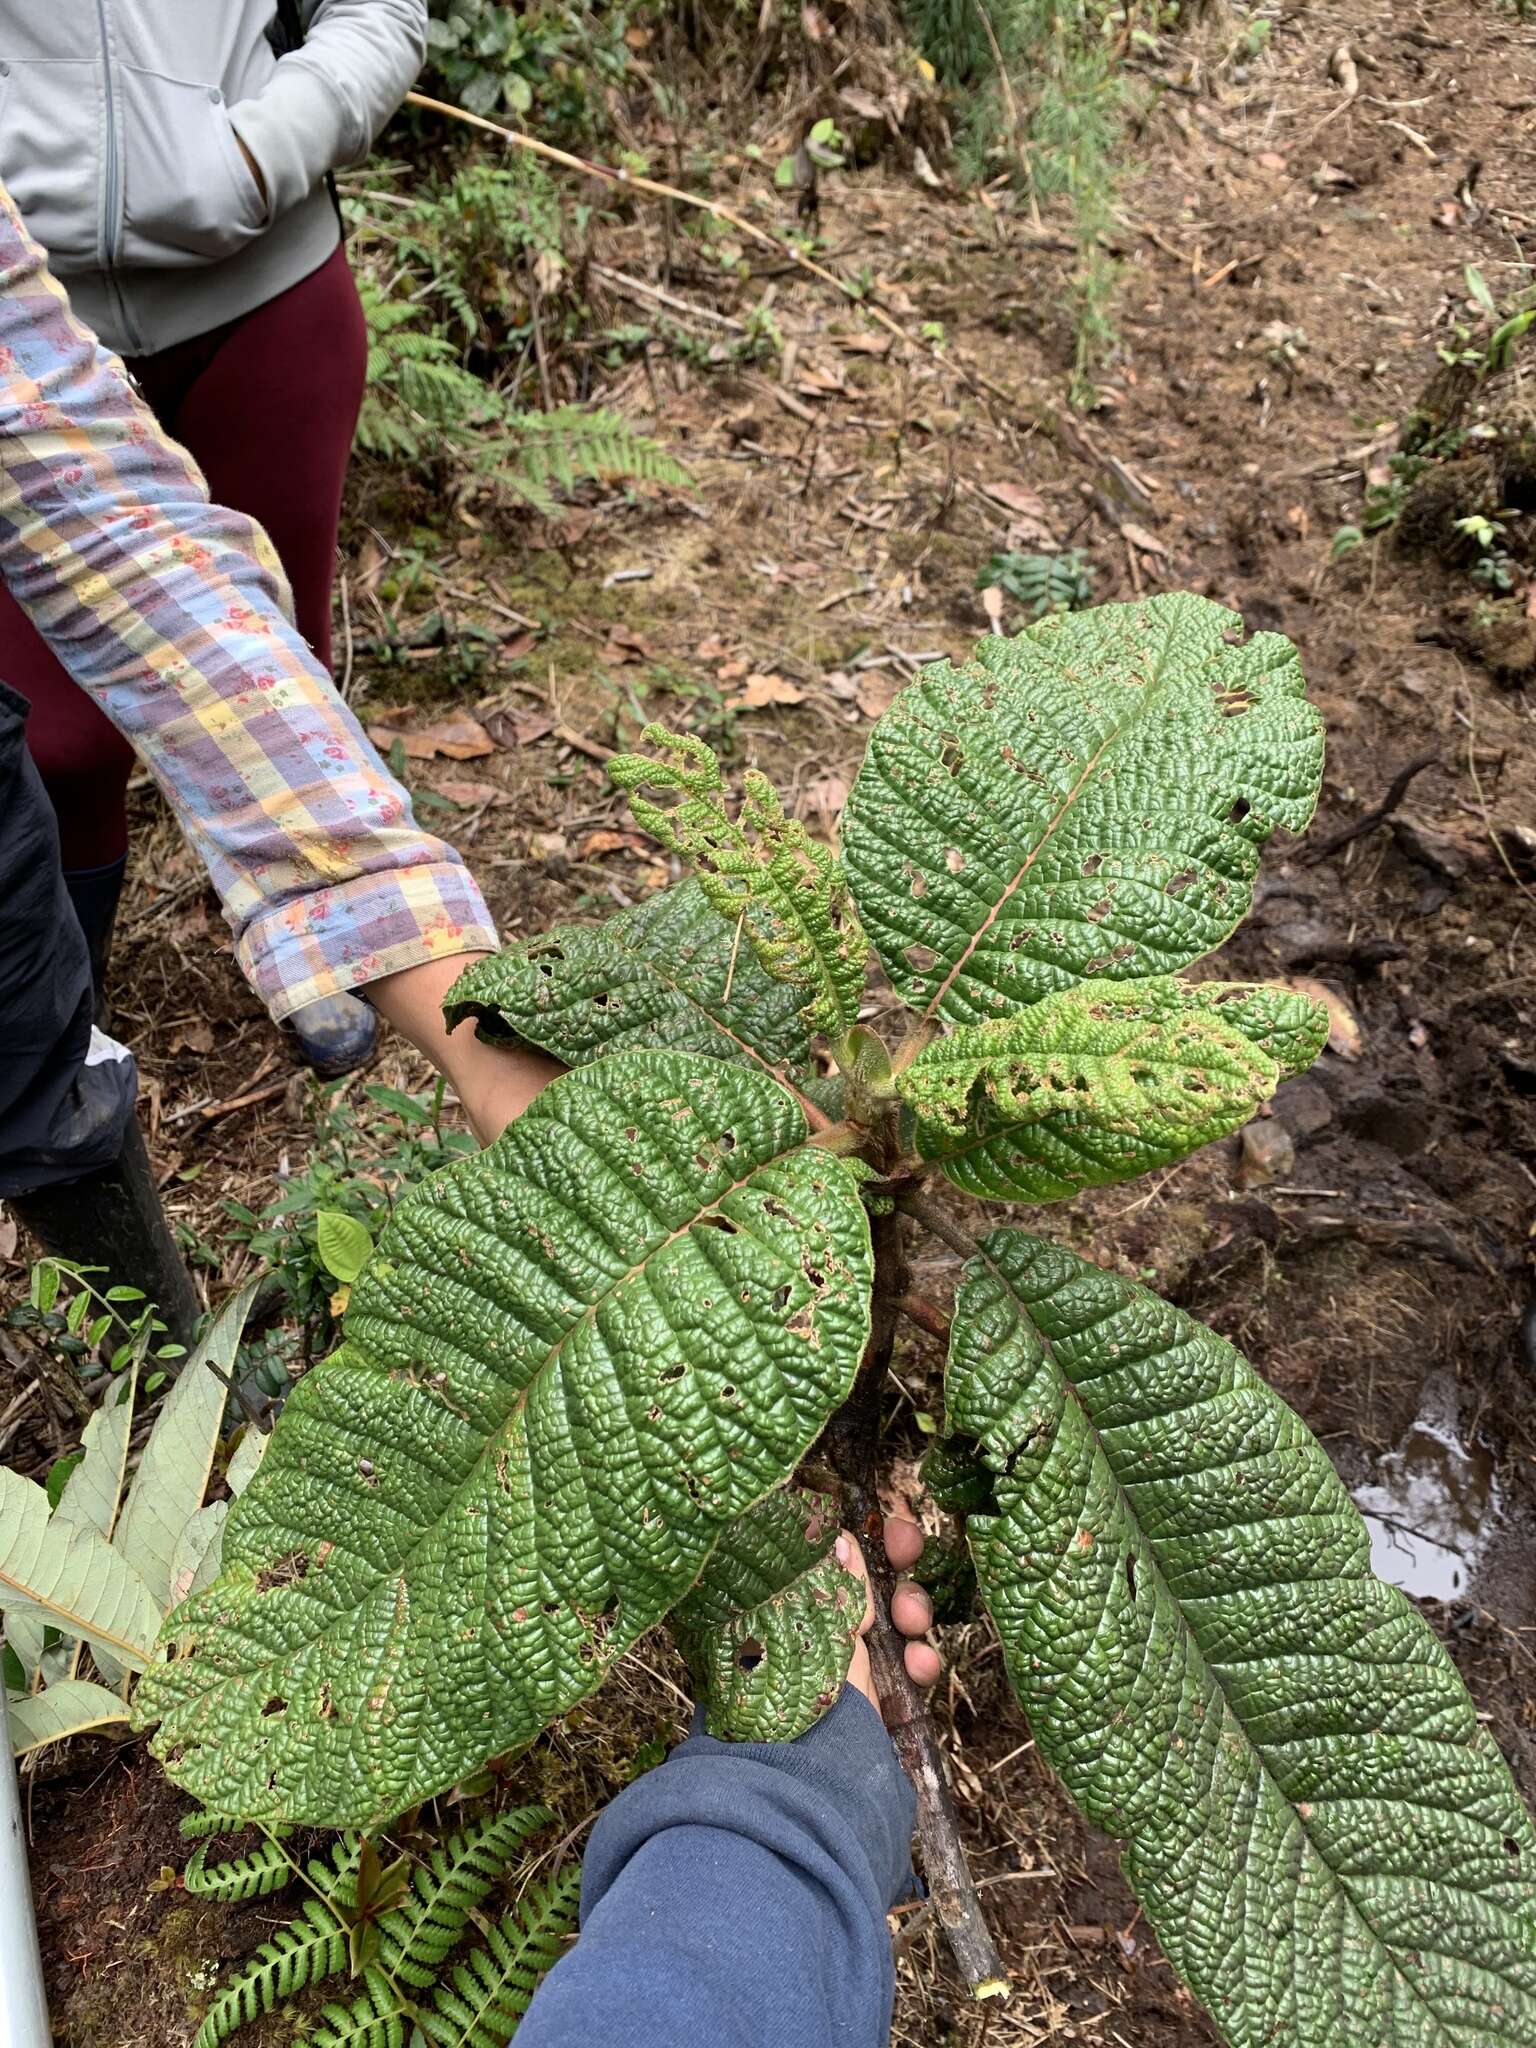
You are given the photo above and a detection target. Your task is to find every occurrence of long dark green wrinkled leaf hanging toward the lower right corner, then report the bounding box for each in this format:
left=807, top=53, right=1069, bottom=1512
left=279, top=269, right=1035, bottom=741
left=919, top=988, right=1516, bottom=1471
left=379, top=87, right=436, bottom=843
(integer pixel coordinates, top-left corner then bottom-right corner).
left=948, top=1231, right=1536, bottom=2048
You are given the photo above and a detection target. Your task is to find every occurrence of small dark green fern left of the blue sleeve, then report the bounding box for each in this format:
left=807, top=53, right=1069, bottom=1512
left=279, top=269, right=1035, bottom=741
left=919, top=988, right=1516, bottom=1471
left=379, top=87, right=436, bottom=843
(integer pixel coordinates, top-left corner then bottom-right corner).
left=182, top=1806, right=580, bottom=2048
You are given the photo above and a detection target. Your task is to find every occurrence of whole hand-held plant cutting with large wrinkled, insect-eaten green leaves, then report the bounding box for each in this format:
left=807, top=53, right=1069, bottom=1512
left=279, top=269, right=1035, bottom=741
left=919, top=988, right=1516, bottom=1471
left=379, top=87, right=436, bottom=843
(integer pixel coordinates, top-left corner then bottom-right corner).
left=135, top=594, right=1536, bottom=2048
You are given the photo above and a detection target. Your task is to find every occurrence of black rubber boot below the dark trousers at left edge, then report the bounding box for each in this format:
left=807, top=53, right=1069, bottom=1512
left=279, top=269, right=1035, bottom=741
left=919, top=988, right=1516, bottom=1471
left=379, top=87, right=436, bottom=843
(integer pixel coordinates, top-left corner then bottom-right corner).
left=8, top=1122, right=203, bottom=1352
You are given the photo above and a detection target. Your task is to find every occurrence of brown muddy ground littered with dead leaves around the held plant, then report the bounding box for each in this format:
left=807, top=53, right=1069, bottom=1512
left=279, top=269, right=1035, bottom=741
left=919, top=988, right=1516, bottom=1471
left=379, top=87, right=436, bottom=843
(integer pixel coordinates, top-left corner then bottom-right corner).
left=0, top=0, right=1536, bottom=2048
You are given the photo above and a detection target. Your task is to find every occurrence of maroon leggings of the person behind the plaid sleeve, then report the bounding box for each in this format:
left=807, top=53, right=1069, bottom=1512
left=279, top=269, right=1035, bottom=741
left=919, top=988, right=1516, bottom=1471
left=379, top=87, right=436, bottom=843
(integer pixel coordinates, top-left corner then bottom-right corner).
left=0, top=248, right=369, bottom=872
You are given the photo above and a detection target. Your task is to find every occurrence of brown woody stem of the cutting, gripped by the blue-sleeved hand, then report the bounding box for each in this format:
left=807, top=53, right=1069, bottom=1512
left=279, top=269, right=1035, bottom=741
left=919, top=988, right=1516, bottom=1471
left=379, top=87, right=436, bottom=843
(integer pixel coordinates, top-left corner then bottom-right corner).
left=823, top=1214, right=1008, bottom=1999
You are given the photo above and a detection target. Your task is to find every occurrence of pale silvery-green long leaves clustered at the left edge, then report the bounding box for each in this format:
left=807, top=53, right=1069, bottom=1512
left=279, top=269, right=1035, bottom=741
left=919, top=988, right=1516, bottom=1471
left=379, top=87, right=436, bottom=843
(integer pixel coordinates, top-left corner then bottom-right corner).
left=0, top=1280, right=266, bottom=1755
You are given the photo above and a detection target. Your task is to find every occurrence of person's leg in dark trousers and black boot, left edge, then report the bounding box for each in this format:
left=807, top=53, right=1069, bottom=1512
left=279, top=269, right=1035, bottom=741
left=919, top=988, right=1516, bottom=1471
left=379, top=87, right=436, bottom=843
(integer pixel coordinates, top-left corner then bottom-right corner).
left=0, top=684, right=201, bottom=1343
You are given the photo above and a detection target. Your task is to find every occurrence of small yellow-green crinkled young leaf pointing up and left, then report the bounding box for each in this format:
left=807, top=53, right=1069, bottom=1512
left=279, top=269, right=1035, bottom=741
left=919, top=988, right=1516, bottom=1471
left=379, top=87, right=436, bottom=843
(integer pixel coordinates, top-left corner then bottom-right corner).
left=608, top=725, right=868, bottom=1038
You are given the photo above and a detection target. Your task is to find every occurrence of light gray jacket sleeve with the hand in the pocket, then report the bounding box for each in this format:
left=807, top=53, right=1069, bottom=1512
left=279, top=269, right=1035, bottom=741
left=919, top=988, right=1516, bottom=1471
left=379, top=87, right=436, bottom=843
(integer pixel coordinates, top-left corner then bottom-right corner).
left=229, top=0, right=426, bottom=217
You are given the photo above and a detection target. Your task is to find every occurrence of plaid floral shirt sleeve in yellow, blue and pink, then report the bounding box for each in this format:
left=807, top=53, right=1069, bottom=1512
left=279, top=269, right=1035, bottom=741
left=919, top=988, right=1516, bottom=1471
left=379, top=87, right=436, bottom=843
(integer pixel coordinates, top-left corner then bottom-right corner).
left=0, top=188, right=496, bottom=1018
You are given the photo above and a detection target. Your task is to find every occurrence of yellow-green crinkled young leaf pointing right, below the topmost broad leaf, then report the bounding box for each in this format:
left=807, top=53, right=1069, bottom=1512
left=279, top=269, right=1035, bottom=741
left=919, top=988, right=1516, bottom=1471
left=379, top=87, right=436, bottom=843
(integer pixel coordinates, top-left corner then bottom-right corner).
left=897, top=979, right=1327, bottom=1202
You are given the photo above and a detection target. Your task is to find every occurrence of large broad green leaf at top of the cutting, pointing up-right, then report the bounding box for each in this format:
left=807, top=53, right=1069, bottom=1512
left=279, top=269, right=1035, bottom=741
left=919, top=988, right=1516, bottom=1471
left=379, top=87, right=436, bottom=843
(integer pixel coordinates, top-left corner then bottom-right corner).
left=842, top=594, right=1323, bottom=1024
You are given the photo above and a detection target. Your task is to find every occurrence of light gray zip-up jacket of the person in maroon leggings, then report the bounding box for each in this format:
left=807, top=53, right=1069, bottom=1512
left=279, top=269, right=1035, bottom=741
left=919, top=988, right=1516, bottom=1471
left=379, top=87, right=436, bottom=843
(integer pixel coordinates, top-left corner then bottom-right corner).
left=0, top=0, right=426, bottom=356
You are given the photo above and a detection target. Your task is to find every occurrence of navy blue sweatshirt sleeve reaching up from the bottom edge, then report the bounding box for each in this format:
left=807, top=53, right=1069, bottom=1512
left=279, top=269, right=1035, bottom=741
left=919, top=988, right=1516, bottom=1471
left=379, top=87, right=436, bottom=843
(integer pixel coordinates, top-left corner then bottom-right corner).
left=516, top=1686, right=913, bottom=2048
